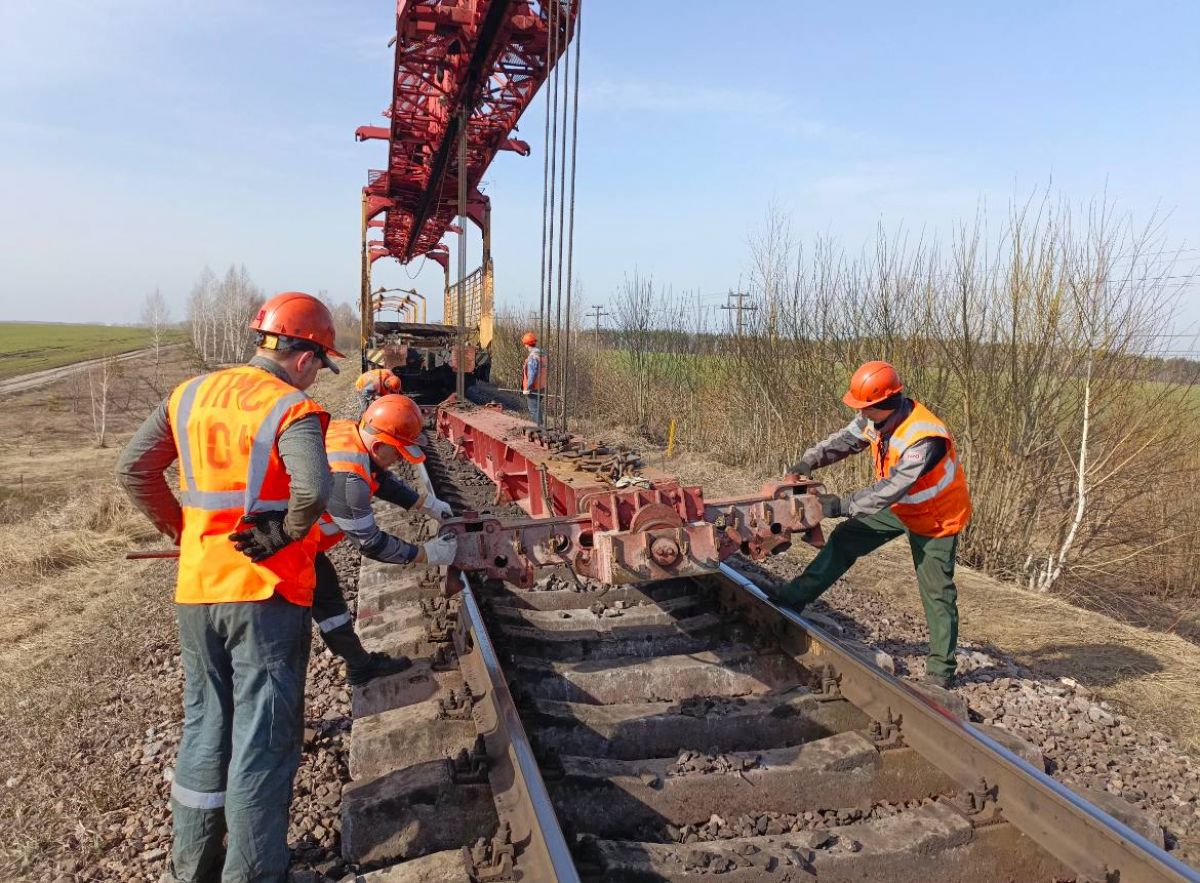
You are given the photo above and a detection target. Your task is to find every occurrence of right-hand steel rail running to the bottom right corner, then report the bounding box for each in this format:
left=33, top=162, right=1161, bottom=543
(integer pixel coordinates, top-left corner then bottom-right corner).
left=720, top=564, right=1200, bottom=883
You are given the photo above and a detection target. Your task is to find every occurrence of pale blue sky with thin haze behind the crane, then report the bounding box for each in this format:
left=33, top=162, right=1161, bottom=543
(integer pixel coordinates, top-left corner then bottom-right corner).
left=0, top=0, right=1200, bottom=345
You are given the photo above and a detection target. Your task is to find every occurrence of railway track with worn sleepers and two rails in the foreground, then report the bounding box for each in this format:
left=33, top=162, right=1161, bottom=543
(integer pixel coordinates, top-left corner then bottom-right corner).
left=343, top=440, right=1200, bottom=883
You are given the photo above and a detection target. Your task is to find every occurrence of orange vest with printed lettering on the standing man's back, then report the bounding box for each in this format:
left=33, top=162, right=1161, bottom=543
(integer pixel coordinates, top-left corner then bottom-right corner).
left=167, top=365, right=329, bottom=607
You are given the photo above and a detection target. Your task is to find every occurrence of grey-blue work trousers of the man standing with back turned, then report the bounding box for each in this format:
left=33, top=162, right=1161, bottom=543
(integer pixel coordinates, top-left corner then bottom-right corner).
left=170, top=595, right=312, bottom=883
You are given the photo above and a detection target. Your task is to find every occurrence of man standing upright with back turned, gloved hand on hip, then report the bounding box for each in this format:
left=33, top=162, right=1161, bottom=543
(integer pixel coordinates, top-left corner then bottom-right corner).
left=118, top=292, right=341, bottom=883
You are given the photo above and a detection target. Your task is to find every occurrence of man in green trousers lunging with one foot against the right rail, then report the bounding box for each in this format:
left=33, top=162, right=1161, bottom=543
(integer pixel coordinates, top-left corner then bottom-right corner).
left=779, top=361, right=971, bottom=687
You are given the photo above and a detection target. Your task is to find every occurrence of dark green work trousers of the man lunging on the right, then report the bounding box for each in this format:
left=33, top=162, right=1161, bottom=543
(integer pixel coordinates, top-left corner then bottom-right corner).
left=779, top=509, right=959, bottom=677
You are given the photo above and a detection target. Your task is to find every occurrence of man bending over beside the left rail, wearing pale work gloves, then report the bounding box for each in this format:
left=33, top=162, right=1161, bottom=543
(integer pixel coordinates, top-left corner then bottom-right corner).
left=312, top=395, right=457, bottom=685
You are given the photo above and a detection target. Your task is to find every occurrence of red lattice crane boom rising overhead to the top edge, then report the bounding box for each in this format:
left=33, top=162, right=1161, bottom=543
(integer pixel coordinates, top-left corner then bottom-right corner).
left=355, top=0, right=577, bottom=263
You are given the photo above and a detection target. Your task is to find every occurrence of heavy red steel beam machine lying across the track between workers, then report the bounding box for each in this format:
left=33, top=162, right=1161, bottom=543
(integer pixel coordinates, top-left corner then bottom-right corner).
left=436, top=400, right=824, bottom=589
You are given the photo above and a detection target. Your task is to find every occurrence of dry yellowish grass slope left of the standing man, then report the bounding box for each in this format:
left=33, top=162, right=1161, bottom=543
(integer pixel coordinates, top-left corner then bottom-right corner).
left=0, top=354, right=354, bottom=881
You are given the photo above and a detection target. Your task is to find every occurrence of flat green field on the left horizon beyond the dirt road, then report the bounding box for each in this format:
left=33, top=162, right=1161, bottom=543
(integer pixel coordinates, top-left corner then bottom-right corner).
left=0, top=322, right=186, bottom=380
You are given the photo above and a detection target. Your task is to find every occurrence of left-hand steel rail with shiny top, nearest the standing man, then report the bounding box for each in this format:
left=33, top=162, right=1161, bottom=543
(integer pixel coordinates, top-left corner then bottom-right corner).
left=456, top=575, right=580, bottom=883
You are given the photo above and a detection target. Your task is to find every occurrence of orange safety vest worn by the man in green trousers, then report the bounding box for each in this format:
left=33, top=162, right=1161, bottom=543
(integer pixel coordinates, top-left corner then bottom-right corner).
left=869, top=402, right=971, bottom=536
